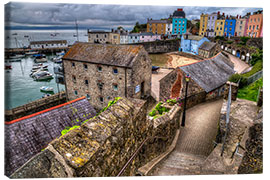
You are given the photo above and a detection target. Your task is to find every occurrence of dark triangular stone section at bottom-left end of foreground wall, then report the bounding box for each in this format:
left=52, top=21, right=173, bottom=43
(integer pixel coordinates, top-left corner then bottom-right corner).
left=10, top=150, right=68, bottom=178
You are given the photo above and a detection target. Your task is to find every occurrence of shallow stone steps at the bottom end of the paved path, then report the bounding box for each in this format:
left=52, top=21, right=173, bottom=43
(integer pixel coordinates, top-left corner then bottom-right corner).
left=150, top=151, right=206, bottom=176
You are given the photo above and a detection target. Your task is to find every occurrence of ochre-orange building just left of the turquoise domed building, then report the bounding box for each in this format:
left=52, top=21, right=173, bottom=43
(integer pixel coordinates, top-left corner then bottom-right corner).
left=146, top=19, right=170, bottom=34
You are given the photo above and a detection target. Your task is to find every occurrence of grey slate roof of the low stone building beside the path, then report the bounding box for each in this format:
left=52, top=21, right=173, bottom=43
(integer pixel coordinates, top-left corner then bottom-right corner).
left=179, top=52, right=234, bottom=93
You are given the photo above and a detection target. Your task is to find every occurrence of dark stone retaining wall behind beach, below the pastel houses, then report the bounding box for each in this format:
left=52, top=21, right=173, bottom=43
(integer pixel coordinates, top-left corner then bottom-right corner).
left=130, top=39, right=180, bottom=53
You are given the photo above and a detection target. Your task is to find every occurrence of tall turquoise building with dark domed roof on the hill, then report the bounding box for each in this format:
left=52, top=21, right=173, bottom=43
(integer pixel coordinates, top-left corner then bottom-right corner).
left=172, top=9, right=187, bottom=35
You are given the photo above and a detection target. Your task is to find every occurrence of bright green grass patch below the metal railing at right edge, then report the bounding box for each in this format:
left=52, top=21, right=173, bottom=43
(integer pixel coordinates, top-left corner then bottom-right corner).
left=237, top=78, right=263, bottom=102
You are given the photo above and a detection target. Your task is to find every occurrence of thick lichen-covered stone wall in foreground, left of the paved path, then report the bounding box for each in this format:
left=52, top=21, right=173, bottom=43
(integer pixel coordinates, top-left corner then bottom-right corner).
left=11, top=98, right=180, bottom=178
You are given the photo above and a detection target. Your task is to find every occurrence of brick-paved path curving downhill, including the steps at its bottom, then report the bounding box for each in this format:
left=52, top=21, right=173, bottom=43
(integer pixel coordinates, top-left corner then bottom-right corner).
left=151, top=99, right=223, bottom=176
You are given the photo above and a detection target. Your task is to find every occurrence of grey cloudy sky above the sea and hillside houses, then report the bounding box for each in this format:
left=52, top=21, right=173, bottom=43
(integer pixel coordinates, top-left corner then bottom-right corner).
left=5, top=2, right=262, bottom=30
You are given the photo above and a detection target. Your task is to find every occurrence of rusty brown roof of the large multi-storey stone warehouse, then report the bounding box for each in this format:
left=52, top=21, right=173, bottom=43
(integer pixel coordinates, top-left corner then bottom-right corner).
left=62, top=42, right=144, bottom=68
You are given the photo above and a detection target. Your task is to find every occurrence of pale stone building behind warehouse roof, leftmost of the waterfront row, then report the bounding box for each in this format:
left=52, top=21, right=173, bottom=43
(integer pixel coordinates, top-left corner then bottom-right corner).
left=88, top=30, right=120, bottom=44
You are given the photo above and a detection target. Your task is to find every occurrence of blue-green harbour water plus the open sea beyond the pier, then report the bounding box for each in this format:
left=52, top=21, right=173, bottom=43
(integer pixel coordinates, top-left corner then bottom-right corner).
left=5, top=30, right=88, bottom=109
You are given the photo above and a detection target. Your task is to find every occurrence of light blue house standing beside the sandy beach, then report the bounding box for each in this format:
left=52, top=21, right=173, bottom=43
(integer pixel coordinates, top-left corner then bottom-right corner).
left=179, top=34, right=210, bottom=55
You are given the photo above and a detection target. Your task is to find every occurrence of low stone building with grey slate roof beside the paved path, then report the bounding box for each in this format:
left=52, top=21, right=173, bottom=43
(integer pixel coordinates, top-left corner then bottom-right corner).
left=159, top=52, right=234, bottom=107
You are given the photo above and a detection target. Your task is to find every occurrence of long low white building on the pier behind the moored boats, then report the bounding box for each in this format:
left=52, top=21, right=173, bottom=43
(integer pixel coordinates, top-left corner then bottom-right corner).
left=30, top=40, right=68, bottom=49
